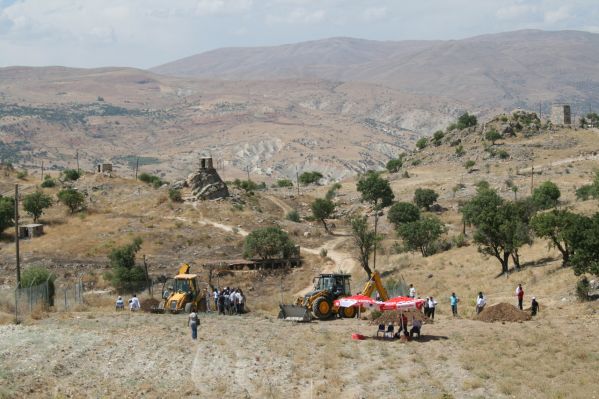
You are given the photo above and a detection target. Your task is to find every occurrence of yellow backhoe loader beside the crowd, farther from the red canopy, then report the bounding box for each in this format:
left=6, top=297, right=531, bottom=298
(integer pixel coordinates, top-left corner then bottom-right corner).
left=152, top=263, right=208, bottom=313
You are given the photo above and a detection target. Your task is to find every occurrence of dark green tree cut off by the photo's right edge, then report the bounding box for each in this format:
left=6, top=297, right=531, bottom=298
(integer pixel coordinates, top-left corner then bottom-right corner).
left=571, top=213, right=599, bottom=276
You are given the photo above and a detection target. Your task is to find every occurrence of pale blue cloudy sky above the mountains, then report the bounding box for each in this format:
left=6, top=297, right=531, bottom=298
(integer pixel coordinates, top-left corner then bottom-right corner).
left=0, top=0, right=599, bottom=68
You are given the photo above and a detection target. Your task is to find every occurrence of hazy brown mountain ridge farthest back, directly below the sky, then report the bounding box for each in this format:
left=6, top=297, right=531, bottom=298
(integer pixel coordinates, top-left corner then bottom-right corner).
left=152, top=30, right=599, bottom=109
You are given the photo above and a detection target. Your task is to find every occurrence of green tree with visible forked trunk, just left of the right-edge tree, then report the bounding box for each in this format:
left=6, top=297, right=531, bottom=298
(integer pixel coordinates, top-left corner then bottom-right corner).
left=531, top=209, right=590, bottom=267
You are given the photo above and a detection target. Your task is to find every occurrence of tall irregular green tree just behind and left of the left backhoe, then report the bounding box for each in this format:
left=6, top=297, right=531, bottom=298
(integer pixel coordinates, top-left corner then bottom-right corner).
left=108, top=237, right=146, bottom=291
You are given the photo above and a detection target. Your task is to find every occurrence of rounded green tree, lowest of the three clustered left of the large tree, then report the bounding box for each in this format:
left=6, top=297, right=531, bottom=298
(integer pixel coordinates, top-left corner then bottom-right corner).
left=397, top=216, right=445, bottom=257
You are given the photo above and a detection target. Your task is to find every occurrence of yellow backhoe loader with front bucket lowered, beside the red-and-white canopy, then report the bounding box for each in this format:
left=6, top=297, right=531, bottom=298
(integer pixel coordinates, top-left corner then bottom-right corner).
left=279, top=271, right=389, bottom=321
